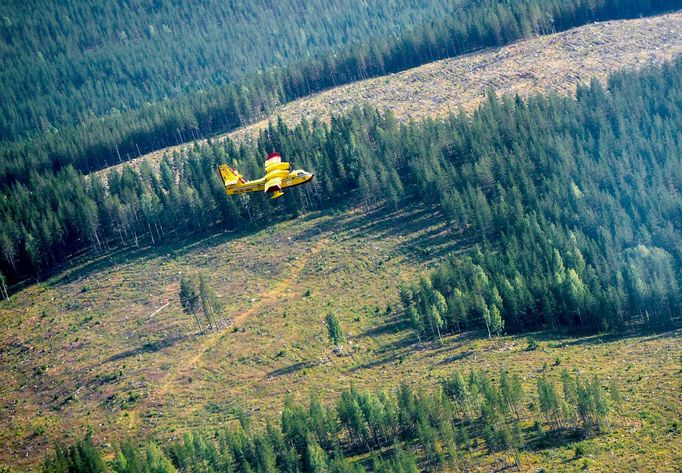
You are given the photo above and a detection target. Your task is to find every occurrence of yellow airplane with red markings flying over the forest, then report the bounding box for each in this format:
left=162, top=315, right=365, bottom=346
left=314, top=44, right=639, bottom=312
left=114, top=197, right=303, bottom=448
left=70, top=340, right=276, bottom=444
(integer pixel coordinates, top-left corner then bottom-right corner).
left=218, top=153, right=314, bottom=199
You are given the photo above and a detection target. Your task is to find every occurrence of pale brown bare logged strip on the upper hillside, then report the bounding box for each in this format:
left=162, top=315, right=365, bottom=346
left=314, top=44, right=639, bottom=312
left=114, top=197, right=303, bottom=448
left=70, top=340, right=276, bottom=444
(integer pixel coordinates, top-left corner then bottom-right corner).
left=98, top=12, right=682, bottom=176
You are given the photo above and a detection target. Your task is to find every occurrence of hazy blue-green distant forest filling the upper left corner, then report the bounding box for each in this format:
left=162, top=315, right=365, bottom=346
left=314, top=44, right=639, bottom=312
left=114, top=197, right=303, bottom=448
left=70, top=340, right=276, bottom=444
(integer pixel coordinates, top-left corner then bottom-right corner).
left=0, top=0, right=456, bottom=139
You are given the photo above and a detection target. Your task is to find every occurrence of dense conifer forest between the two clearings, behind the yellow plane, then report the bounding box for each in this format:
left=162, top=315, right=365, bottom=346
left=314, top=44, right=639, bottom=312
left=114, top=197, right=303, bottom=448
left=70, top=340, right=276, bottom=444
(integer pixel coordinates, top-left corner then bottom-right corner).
left=0, top=57, right=682, bottom=337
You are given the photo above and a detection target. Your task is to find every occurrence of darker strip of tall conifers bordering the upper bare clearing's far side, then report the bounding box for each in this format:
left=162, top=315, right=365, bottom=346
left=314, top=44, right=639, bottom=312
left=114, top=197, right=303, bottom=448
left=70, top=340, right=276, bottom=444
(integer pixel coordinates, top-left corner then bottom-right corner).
left=0, top=0, right=682, bottom=183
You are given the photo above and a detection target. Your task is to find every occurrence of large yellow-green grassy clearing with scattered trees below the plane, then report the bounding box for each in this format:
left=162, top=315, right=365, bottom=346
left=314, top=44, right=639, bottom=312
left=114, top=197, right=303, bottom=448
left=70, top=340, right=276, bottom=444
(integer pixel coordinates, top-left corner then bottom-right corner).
left=0, top=201, right=682, bottom=471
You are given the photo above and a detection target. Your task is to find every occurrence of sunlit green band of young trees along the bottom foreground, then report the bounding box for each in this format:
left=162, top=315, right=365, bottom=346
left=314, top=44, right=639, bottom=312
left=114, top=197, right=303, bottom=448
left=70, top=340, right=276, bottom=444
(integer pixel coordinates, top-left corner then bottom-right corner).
left=43, top=370, right=621, bottom=473
